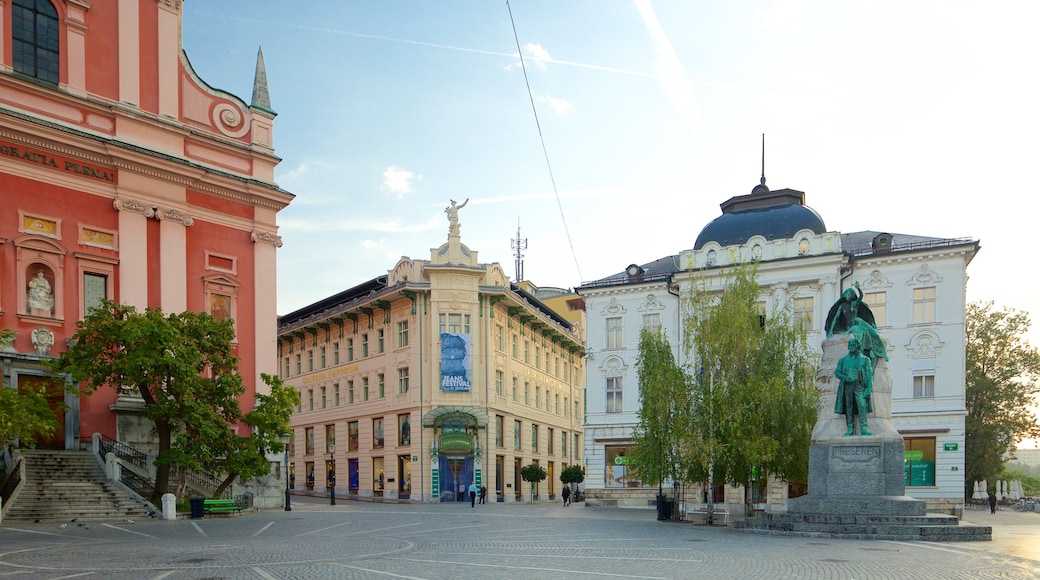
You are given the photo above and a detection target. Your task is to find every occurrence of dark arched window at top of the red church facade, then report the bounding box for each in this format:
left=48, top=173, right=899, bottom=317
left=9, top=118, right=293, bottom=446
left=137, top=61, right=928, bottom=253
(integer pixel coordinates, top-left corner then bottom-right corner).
left=11, top=0, right=58, bottom=84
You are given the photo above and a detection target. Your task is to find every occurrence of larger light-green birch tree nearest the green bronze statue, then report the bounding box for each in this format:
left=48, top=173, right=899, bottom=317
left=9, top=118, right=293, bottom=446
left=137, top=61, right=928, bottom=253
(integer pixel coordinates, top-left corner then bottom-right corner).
left=680, top=264, right=818, bottom=517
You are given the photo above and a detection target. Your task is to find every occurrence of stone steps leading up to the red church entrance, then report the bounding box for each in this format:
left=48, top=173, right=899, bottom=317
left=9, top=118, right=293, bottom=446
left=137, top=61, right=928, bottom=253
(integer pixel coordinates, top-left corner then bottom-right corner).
left=4, top=450, right=156, bottom=522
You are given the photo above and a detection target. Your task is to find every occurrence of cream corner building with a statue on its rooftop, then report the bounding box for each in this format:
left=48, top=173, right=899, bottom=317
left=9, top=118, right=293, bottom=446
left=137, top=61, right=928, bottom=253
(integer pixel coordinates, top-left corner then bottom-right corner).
left=278, top=209, right=586, bottom=502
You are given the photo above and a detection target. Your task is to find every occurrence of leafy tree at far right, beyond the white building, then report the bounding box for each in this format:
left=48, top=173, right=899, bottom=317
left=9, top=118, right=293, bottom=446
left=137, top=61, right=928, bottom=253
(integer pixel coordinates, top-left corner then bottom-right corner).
left=964, top=301, right=1040, bottom=497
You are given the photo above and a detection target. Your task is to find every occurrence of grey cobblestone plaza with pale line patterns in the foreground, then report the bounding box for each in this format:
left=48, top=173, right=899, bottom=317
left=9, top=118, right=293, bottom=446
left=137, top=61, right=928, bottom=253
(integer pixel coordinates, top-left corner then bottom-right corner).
left=0, top=498, right=1040, bottom=580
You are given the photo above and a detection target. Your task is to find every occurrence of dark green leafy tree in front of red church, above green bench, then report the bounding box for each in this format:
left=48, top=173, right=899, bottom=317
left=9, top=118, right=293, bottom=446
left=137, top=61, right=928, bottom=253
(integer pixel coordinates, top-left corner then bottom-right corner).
left=52, top=300, right=298, bottom=499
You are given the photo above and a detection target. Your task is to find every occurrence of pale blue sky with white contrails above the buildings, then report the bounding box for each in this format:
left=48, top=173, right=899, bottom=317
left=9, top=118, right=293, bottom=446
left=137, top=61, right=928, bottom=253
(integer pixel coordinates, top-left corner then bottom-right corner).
left=183, top=0, right=1040, bottom=442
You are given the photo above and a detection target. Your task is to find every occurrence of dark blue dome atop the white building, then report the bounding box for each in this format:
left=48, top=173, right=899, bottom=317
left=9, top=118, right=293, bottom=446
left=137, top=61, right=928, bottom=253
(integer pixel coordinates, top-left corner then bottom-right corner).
left=694, top=186, right=827, bottom=249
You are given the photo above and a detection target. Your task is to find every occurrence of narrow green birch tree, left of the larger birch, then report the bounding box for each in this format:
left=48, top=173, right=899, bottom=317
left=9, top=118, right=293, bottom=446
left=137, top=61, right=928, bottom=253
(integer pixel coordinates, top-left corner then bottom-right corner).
left=628, top=328, right=693, bottom=498
